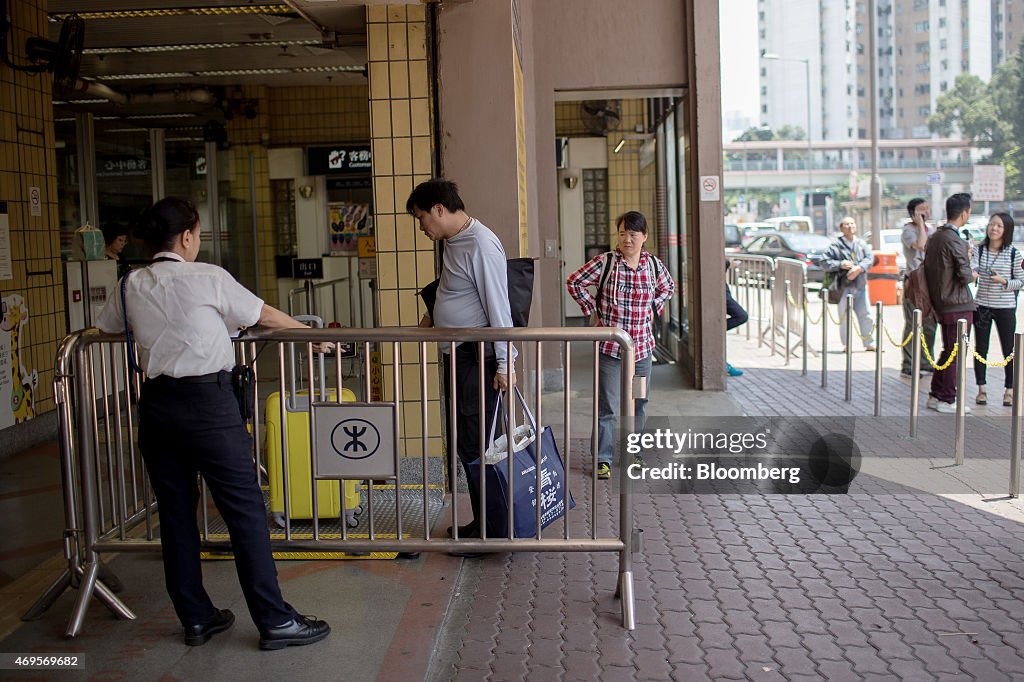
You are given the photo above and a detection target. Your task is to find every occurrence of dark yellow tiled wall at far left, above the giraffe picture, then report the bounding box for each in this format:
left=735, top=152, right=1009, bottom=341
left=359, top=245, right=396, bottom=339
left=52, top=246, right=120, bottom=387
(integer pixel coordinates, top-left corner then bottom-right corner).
left=0, top=0, right=67, bottom=415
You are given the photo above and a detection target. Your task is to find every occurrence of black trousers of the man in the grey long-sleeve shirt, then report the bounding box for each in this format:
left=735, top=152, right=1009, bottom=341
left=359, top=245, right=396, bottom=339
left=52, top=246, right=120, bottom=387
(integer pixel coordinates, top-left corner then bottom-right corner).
left=443, top=343, right=498, bottom=536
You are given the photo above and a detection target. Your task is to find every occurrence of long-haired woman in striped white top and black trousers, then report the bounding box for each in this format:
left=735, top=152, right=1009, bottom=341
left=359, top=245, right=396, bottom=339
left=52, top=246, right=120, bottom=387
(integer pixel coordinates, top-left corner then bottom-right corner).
left=971, top=213, right=1024, bottom=406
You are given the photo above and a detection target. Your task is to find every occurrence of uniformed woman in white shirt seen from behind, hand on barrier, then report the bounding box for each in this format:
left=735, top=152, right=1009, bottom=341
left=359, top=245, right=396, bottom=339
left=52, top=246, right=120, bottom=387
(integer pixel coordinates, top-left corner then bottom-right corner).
left=97, top=198, right=331, bottom=649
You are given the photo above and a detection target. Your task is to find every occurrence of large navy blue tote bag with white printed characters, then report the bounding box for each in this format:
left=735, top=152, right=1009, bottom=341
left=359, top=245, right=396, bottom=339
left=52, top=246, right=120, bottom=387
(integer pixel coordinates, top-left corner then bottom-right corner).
left=468, top=388, right=575, bottom=538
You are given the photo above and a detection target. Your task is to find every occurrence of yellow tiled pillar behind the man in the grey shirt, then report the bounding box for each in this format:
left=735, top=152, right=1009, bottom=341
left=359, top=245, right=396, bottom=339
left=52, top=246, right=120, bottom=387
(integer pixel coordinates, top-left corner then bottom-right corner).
left=367, top=4, right=442, bottom=456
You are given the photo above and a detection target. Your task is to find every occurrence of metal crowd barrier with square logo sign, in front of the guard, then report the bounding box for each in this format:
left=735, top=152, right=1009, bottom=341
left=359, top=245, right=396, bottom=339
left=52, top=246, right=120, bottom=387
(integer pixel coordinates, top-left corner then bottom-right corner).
left=24, top=328, right=646, bottom=637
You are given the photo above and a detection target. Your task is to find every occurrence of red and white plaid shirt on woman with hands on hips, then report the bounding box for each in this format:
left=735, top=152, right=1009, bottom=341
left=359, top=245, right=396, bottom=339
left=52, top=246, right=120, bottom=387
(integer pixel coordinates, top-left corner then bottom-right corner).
left=565, top=246, right=676, bottom=360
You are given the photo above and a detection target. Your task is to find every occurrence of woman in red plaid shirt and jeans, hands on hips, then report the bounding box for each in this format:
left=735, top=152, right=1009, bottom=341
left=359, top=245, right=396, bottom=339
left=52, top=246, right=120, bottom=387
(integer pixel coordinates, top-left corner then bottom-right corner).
left=565, top=211, right=676, bottom=478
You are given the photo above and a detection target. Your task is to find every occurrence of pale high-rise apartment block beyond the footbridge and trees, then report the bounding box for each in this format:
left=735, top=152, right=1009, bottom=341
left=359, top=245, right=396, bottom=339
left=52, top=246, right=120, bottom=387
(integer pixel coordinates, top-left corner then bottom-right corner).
left=758, top=0, right=1024, bottom=139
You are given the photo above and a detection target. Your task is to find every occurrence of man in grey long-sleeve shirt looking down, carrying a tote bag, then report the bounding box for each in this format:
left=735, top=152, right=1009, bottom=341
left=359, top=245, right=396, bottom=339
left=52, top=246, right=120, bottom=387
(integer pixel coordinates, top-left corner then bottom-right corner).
left=406, top=179, right=516, bottom=538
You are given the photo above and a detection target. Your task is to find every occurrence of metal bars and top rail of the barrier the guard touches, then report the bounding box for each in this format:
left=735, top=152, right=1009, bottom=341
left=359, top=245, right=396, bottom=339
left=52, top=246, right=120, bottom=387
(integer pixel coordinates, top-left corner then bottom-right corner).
left=26, top=328, right=635, bottom=637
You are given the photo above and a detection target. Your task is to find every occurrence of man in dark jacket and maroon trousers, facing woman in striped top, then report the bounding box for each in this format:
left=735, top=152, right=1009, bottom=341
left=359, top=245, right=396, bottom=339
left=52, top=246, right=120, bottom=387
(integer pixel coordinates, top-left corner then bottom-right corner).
left=925, top=194, right=975, bottom=414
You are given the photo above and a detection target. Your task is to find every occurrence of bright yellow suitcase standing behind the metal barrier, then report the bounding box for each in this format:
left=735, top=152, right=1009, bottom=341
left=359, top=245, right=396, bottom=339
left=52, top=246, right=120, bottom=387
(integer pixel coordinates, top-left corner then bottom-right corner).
left=264, top=388, right=362, bottom=527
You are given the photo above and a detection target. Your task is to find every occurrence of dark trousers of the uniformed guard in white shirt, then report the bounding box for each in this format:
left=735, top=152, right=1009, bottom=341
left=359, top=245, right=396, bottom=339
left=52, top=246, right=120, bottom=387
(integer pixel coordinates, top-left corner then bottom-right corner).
left=138, top=372, right=295, bottom=632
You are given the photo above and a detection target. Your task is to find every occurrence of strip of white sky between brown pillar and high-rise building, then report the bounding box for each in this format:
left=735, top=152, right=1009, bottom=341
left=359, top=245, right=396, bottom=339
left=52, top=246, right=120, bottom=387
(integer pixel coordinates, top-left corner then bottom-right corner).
left=719, top=0, right=761, bottom=125
